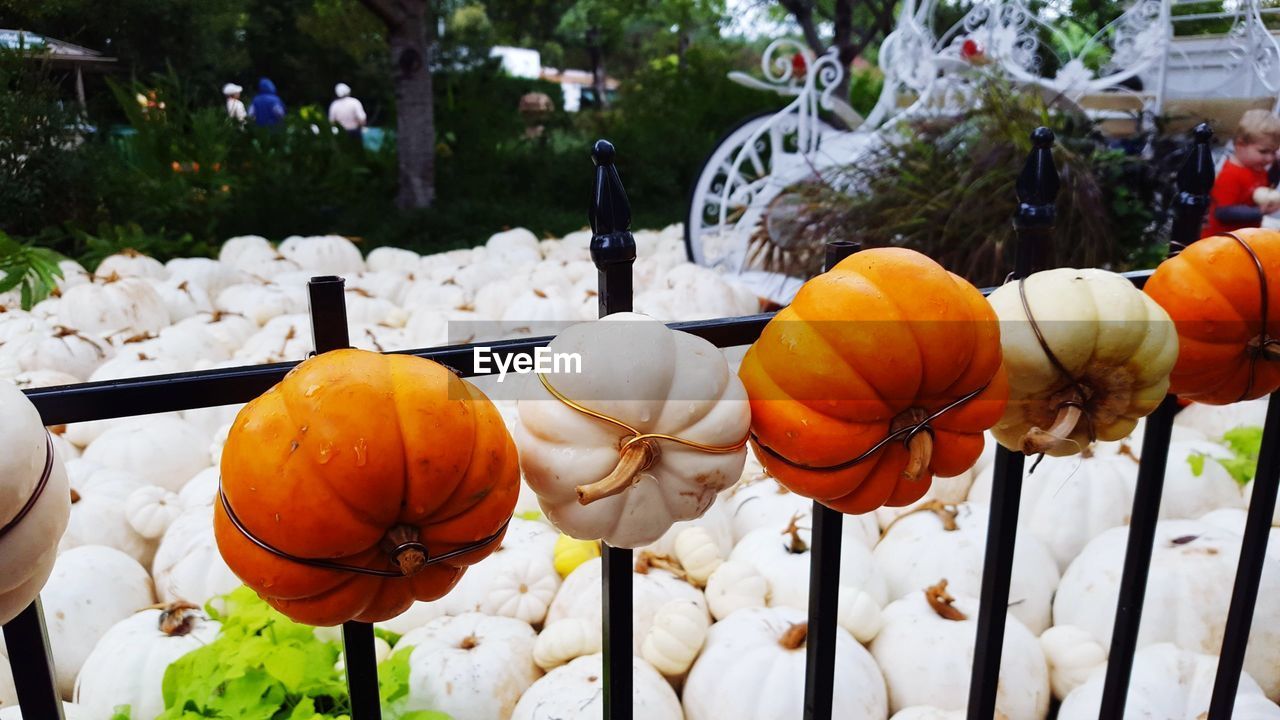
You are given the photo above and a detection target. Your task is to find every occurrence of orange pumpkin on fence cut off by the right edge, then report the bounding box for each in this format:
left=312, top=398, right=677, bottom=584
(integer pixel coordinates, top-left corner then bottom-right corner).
left=1144, top=228, right=1280, bottom=405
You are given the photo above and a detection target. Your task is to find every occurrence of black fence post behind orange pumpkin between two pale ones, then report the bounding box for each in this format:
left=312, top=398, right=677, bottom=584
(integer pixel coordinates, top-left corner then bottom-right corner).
left=804, top=240, right=861, bottom=720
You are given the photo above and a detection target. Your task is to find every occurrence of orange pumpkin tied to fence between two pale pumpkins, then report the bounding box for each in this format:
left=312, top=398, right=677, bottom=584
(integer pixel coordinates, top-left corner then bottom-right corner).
left=739, top=249, right=1009, bottom=514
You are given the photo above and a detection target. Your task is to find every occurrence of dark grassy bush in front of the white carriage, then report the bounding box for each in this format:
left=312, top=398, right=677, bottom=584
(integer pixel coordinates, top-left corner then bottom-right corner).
left=753, top=76, right=1160, bottom=286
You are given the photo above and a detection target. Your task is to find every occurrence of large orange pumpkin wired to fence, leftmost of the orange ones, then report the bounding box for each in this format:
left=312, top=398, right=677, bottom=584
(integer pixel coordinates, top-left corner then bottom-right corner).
left=214, top=350, right=520, bottom=625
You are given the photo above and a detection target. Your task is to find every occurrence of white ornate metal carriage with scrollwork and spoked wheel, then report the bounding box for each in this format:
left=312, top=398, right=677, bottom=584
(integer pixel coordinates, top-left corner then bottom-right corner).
left=685, top=0, right=1280, bottom=304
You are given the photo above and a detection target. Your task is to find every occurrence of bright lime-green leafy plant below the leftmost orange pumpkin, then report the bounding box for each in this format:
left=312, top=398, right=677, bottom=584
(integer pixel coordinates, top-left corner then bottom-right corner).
left=155, top=587, right=448, bottom=720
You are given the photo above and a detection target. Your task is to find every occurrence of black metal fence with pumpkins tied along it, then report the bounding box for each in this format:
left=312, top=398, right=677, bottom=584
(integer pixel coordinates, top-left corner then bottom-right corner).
left=4, top=126, right=1280, bottom=720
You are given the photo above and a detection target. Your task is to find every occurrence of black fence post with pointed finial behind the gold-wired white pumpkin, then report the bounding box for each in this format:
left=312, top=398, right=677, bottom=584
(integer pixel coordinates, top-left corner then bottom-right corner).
left=588, top=140, right=636, bottom=720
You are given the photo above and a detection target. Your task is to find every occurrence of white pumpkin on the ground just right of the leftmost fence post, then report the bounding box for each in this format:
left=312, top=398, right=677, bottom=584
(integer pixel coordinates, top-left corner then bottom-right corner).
left=40, top=544, right=155, bottom=700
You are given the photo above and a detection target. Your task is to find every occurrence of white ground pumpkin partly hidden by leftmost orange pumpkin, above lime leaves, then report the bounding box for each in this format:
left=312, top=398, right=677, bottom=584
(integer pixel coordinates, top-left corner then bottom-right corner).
left=151, top=505, right=241, bottom=603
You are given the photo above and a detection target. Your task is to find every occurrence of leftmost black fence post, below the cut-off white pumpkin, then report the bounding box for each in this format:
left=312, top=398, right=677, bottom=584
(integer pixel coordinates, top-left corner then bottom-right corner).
left=4, top=596, right=63, bottom=720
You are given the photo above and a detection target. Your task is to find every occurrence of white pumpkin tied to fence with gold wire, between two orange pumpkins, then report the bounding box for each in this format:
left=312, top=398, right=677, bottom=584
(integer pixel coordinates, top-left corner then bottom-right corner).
left=515, top=313, right=750, bottom=547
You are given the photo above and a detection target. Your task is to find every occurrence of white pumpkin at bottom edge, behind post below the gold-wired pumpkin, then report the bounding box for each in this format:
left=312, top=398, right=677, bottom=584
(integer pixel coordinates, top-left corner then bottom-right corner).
left=511, top=653, right=685, bottom=720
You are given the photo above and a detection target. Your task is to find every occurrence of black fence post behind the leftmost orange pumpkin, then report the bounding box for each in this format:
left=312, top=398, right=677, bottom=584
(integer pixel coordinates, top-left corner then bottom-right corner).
left=307, top=275, right=383, bottom=720
